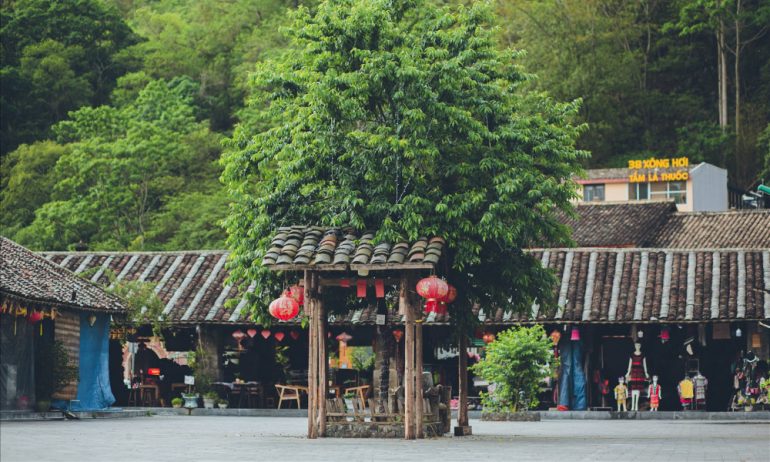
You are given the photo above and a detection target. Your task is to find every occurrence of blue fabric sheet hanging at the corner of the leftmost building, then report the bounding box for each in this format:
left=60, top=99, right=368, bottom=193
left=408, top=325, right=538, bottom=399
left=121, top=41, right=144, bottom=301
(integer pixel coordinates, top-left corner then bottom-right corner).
left=72, top=313, right=115, bottom=411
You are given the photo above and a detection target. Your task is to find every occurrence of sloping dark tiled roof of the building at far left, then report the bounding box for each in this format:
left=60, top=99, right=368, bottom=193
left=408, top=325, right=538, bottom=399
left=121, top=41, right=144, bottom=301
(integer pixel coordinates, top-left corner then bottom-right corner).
left=0, top=236, right=124, bottom=311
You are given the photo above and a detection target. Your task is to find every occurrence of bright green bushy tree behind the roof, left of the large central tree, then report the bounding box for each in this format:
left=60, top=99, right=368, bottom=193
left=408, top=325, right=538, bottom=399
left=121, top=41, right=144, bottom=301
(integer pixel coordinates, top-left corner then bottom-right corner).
left=15, top=79, right=225, bottom=253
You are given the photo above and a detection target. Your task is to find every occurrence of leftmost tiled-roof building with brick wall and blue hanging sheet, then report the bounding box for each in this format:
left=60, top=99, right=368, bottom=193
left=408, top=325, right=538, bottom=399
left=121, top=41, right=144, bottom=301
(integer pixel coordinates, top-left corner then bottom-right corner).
left=0, top=237, right=125, bottom=412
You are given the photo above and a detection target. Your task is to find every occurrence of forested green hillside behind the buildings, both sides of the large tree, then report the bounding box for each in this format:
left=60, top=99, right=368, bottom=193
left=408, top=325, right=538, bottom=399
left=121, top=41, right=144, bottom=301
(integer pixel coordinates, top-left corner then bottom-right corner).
left=0, top=0, right=770, bottom=250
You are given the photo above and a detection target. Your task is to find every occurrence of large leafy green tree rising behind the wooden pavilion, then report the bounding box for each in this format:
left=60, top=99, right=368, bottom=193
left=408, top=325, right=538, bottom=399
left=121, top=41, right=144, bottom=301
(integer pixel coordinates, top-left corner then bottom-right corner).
left=223, top=0, right=587, bottom=324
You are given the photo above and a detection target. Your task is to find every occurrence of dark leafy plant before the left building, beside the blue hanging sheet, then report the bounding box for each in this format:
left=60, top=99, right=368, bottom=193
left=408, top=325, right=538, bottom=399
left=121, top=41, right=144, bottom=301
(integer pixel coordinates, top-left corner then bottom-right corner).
left=35, top=340, right=78, bottom=401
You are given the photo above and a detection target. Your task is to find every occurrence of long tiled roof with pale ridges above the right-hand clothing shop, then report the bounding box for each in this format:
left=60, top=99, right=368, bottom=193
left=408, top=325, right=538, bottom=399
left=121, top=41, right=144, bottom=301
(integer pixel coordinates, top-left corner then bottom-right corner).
left=474, top=248, right=770, bottom=324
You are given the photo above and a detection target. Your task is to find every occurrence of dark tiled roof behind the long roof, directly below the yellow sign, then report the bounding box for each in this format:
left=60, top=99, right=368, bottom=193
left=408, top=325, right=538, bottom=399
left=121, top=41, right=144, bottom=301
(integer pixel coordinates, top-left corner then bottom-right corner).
left=558, top=202, right=672, bottom=247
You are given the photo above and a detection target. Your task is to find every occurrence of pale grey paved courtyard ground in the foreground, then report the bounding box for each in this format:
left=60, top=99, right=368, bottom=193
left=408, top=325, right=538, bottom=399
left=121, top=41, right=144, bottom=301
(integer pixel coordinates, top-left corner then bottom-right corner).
left=0, top=416, right=770, bottom=462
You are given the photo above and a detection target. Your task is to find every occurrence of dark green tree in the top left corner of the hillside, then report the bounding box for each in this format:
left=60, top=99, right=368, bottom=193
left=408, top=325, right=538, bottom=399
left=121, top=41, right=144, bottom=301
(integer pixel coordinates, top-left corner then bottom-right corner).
left=0, top=0, right=136, bottom=154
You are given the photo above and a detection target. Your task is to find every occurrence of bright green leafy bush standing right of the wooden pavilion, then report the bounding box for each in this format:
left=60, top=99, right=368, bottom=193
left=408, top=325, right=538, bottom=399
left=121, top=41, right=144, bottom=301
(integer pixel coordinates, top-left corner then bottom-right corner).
left=470, top=325, right=557, bottom=412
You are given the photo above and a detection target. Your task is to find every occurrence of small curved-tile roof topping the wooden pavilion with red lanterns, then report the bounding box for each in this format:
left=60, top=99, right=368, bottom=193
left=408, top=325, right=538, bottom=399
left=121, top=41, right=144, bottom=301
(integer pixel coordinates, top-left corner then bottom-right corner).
left=262, top=226, right=444, bottom=270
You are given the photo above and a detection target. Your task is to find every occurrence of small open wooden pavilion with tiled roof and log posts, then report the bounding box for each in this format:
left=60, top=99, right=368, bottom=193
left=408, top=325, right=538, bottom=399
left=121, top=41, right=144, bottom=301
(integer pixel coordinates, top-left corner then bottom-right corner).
left=262, top=226, right=469, bottom=439
